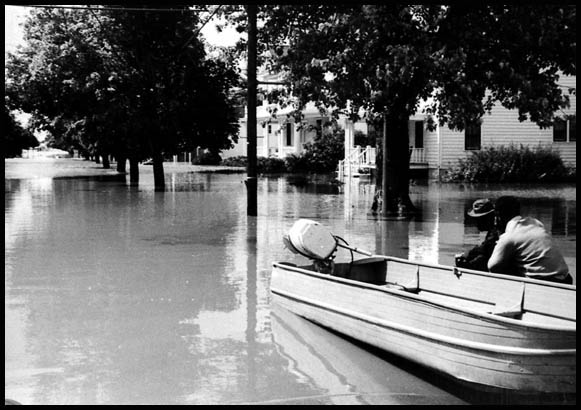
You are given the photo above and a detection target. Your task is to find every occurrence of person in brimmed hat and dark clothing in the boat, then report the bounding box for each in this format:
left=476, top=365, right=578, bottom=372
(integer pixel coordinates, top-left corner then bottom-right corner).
left=455, top=198, right=498, bottom=271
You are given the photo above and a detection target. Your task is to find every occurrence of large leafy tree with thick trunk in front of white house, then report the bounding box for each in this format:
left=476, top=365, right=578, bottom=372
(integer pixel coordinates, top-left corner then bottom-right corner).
left=232, top=4, right=576, bottom=213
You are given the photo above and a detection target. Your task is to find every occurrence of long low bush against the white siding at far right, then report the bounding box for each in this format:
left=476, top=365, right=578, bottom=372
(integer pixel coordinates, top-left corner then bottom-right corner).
left=444, top=144, right=576, bottom=182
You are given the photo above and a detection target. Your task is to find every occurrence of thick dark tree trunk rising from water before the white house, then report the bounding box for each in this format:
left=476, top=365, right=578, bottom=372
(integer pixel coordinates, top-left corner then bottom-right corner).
left=372, top=110, right=418, bottom=216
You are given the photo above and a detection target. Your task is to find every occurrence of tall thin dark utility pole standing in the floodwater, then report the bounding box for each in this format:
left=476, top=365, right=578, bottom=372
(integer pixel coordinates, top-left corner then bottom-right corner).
left=246, top=4, right=258, bottom=216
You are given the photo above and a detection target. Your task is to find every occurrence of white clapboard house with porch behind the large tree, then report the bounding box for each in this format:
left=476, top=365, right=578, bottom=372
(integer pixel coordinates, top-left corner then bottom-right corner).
left=222, top=76, right=577, bottom=178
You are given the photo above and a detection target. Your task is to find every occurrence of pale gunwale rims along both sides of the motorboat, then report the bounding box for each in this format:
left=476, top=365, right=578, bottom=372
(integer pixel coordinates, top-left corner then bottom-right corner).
left=273, top=255, right=577, bottom=334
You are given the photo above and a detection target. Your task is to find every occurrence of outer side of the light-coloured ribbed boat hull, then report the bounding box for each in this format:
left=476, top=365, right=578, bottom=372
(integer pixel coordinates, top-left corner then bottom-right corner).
left=271, top=264, right=576, bottom=393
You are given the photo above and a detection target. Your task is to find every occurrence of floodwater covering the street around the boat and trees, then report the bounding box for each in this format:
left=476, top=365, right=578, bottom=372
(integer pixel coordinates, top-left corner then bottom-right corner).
left=4, top=159, right=577, bottom=405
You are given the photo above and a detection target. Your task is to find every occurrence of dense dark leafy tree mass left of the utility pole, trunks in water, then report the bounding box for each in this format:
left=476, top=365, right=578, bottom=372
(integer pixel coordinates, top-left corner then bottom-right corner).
left=7, top=6, right=238, bottom=190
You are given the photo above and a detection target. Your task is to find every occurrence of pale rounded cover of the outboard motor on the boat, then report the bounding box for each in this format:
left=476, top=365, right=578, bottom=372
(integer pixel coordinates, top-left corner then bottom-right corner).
left=288, top=219, right=337, bottom=259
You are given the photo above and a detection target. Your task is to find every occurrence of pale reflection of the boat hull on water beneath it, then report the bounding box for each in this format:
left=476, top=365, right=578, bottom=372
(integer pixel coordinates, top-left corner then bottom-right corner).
left=269, top=306, right=465, bottom=405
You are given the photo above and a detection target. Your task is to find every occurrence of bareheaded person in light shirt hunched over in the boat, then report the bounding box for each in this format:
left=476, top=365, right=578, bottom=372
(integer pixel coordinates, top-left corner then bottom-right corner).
left=487, top=196, right=573, bottom=284
